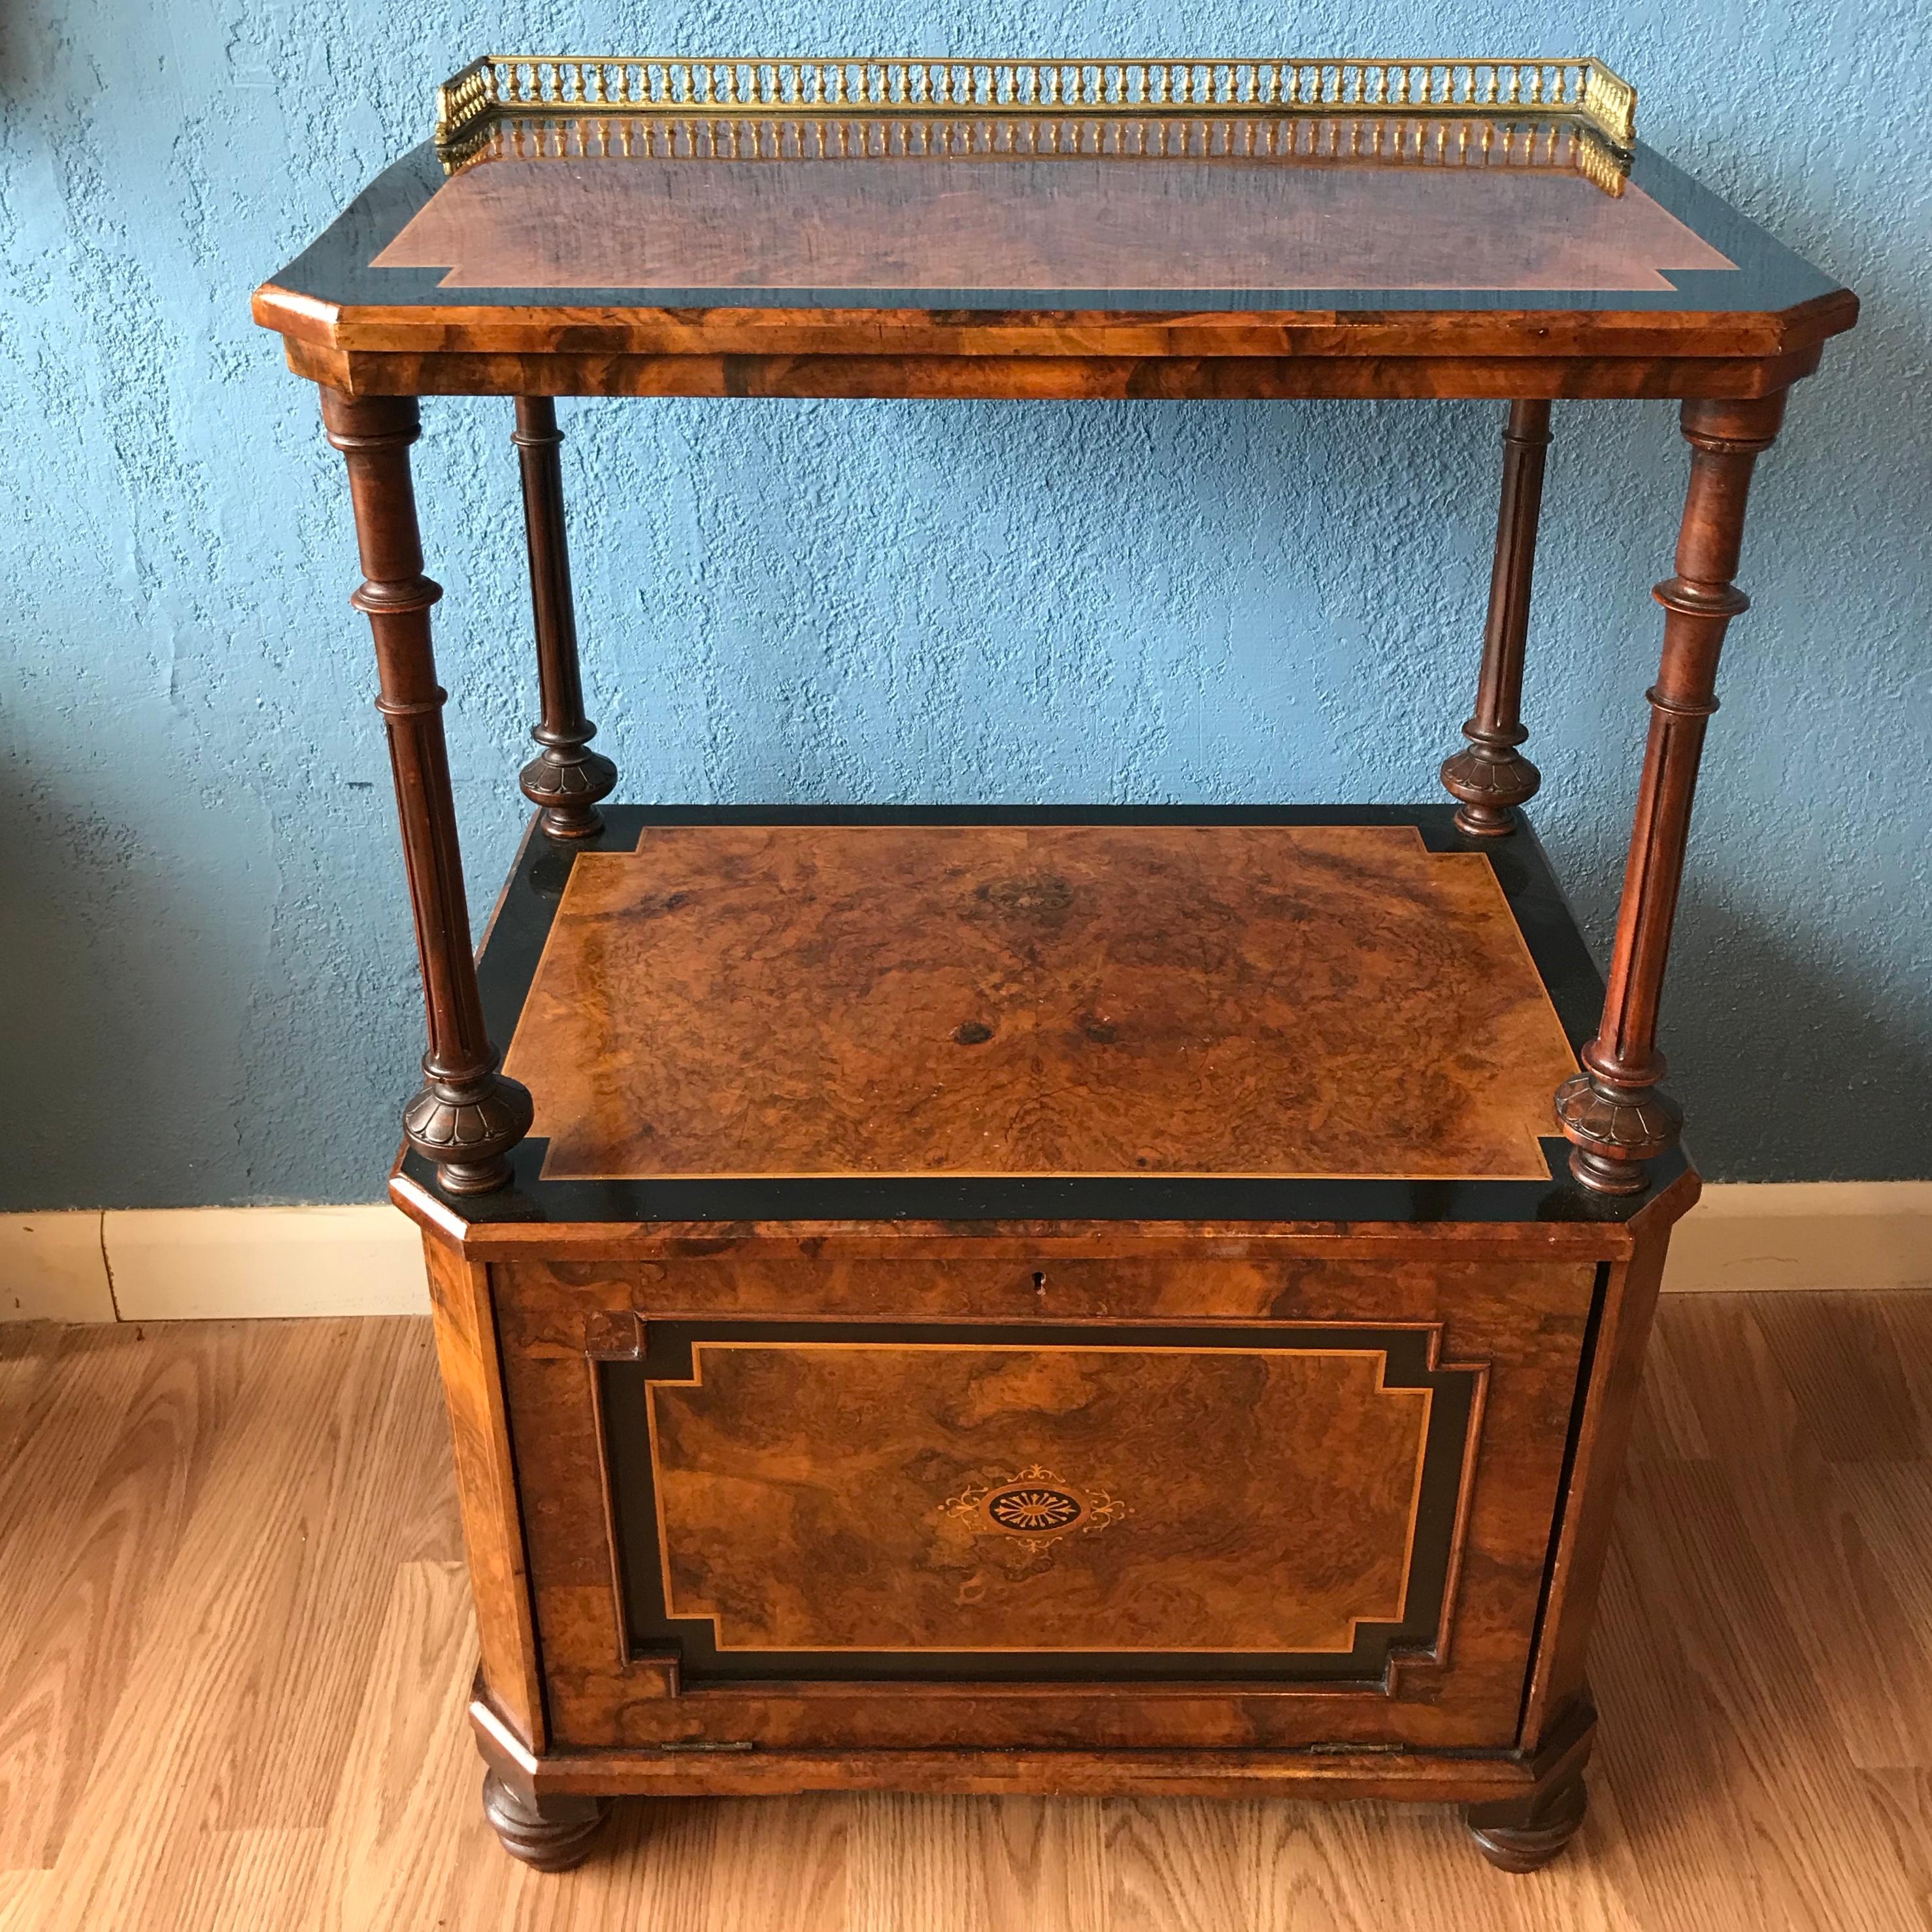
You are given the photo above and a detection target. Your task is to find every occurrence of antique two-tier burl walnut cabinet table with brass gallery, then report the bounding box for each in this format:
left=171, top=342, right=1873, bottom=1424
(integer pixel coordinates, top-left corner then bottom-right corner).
left=255, top=56, right=1857, bottom=1870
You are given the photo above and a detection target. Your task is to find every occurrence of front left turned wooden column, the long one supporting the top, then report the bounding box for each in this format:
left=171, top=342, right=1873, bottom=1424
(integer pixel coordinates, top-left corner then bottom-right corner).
left=323, top=388, right=531, bottom=1194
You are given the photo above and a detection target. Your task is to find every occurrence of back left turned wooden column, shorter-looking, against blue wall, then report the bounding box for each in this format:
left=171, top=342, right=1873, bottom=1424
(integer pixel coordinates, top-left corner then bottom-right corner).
left=510, top=396, right=616, bottom=839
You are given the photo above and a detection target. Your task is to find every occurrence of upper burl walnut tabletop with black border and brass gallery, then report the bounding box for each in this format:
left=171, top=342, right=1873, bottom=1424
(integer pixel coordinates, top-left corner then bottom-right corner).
left=257, top=56, right=1855, bottom=396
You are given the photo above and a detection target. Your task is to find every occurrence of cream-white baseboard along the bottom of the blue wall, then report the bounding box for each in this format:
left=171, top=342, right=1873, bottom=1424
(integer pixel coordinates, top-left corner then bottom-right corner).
left=0, top=1180, right=1932, bottom=1322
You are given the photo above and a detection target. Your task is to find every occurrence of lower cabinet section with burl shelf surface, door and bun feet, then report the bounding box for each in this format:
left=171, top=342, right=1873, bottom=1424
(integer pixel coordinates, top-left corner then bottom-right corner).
left=392, top=806, right=1696, bottom=1868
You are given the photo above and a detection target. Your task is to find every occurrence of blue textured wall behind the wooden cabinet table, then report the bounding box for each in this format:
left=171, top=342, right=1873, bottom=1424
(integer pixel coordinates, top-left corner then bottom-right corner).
left=0, top=0, right=1932, bottom=1208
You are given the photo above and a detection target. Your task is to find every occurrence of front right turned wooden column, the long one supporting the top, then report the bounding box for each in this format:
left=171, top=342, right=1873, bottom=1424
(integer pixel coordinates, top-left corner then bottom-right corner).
left=1557, top=394, right=1785, bottom=1194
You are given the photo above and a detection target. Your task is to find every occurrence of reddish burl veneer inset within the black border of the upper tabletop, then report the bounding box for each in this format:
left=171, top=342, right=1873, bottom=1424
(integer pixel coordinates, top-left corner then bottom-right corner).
left=375, top=156, right=1735, bottom=291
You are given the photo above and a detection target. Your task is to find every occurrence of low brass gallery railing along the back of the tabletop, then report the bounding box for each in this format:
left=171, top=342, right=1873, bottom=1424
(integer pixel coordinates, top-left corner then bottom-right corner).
left=437, top=54, right=1637, bottom=166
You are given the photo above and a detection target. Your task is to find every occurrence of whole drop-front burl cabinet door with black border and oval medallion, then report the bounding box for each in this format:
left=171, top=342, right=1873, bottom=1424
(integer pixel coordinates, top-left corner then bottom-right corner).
left=491, top=1244, right=1599, bottom=1750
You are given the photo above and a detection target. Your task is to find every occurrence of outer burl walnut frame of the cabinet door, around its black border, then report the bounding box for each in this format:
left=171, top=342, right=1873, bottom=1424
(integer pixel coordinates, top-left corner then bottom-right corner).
left=493, top=1244, right=1594, bottom=1761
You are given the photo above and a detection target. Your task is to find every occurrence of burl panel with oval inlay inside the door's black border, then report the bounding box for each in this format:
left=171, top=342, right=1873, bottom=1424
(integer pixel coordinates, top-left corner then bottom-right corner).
left=649, top=1337, right=1431, bottom=1652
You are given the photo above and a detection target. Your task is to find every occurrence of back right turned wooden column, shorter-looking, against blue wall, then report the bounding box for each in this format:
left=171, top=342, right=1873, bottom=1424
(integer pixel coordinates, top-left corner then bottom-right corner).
left=1441, top=402, right=1550, bottom=839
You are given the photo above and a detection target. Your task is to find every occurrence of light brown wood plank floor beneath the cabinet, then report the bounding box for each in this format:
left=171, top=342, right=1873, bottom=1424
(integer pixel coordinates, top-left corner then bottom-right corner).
left=0, top=1293, right=1932, bottom=1932
